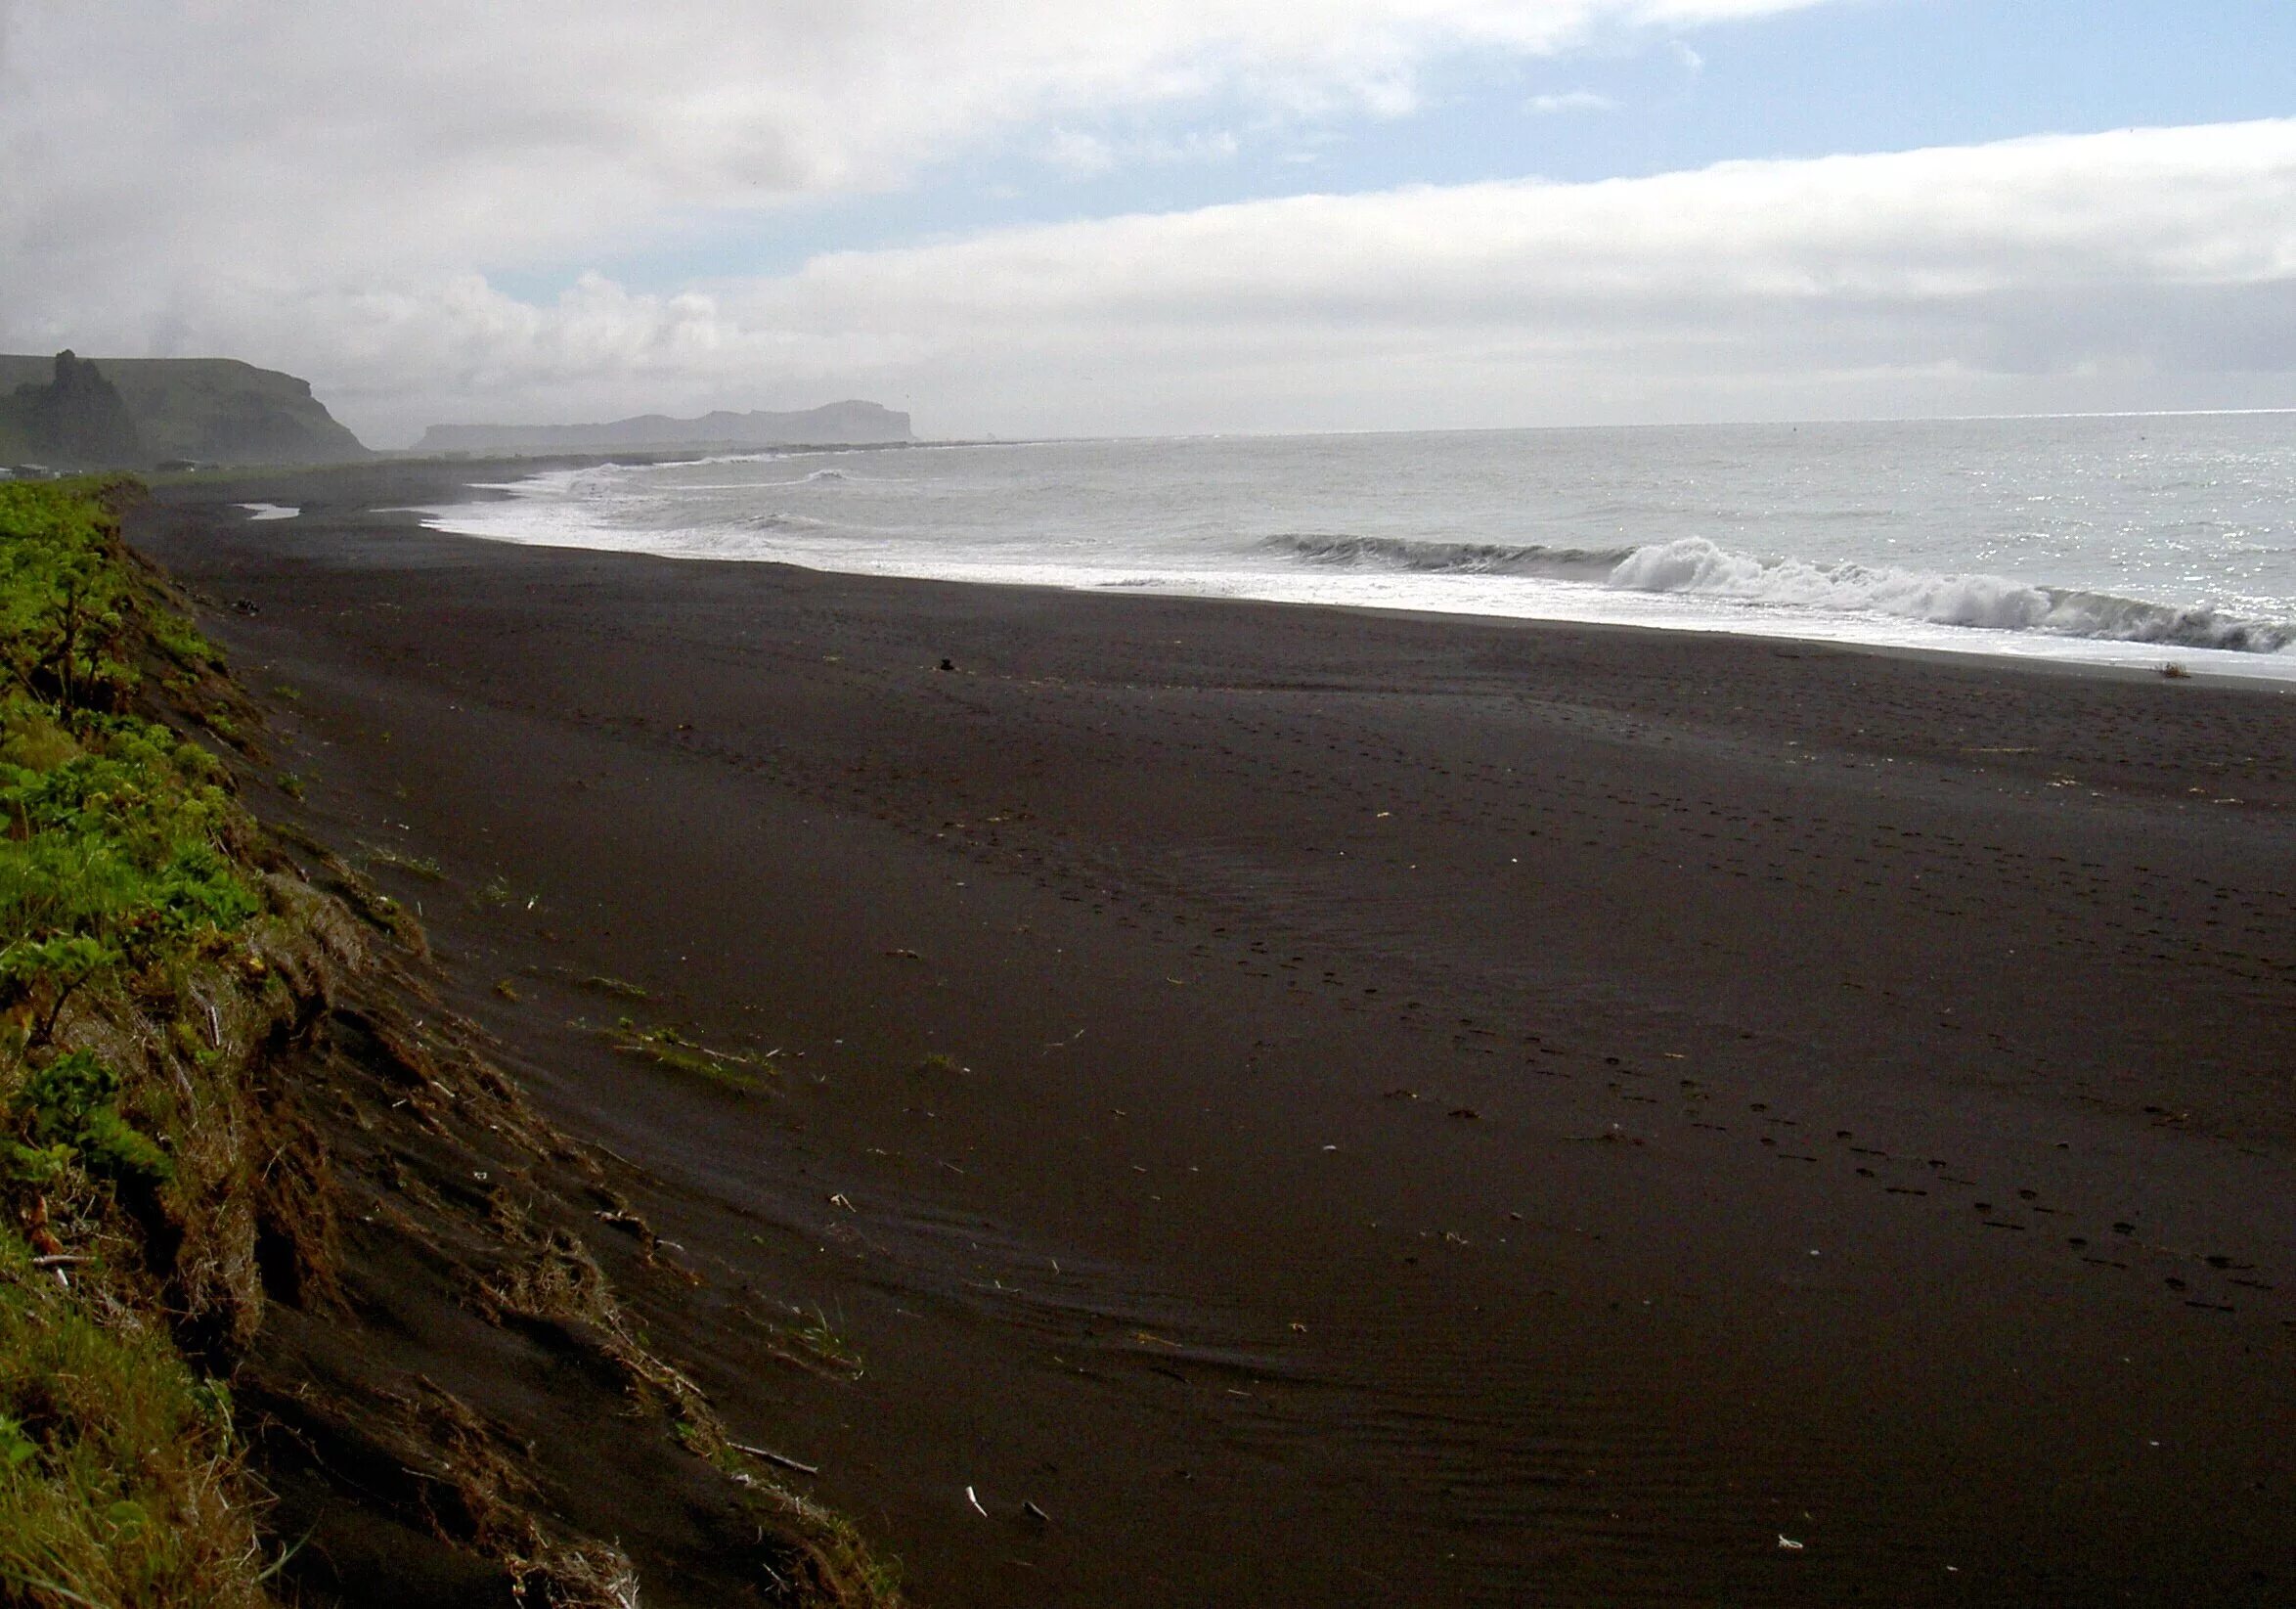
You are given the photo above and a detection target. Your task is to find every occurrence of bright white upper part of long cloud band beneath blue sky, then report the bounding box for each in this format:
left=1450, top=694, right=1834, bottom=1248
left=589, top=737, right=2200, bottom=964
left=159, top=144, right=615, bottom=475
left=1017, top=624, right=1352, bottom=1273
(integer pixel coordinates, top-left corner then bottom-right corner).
left=751, top=121, right=2296, bottom=337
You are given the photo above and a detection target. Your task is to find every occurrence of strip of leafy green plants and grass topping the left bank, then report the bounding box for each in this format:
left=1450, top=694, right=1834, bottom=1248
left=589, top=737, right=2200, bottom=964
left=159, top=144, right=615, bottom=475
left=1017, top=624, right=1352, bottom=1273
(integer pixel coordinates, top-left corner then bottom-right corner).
left=0, top=470, right=281, bottom=1607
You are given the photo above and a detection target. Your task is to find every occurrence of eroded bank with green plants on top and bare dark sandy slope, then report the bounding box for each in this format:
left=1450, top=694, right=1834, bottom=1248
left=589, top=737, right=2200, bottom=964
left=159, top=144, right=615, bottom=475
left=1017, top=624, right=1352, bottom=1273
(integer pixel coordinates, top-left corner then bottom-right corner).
left=0, top=479, right=896, bottom=1604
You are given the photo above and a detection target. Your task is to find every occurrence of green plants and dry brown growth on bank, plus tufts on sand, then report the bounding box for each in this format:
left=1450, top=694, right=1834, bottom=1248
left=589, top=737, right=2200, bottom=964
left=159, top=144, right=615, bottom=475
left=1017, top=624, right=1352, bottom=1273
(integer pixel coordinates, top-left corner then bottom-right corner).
left=0, top=479, right=898, bottom=1609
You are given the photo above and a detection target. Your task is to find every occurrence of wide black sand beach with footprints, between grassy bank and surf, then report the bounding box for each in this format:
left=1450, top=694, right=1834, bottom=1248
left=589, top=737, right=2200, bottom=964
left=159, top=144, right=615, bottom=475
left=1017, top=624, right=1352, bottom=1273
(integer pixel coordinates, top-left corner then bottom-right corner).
left=131, top=466, right=2296, bottom=1607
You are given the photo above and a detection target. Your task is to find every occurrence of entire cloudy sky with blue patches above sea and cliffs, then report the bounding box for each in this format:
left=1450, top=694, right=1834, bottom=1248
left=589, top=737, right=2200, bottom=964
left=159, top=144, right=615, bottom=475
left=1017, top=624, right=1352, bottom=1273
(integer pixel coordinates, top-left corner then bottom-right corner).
left=0, top=0, right=2296, bottom=448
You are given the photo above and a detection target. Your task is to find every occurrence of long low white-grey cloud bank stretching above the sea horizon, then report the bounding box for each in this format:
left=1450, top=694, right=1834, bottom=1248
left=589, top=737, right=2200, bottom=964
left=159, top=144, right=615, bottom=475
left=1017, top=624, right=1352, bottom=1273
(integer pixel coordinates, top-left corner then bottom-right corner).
left=134, top=121, right=2296, bottom=438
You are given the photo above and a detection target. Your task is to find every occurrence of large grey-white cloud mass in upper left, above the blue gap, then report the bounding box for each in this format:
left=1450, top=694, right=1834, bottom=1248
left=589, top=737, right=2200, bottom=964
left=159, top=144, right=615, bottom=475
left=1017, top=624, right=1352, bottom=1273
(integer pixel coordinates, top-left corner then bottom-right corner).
left=0, top=0, right=1826, bottom=285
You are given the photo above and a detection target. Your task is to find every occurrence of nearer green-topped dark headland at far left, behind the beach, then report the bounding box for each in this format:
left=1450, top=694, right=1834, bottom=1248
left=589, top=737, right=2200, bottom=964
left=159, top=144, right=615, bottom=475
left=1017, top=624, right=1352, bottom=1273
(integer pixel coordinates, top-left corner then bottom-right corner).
left=0, top=353, right=370, bottom=469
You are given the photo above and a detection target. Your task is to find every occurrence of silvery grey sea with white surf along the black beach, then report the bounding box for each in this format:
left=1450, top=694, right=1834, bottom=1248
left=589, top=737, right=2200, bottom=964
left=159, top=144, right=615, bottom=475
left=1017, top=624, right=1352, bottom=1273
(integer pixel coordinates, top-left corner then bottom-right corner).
left=424, top=413, right=2296, bottom=680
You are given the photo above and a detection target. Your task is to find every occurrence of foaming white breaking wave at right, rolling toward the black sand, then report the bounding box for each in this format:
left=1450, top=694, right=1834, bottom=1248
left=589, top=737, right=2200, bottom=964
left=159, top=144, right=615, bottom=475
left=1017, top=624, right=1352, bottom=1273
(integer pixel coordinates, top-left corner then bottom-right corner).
left=1610, top=537, right=2296, bottom=654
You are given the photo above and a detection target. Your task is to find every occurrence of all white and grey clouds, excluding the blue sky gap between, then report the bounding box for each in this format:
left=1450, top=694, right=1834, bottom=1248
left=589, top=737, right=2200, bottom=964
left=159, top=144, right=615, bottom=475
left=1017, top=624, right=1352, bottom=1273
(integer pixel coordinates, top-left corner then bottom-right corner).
left=0, top=0, right=2296, bottom=441
